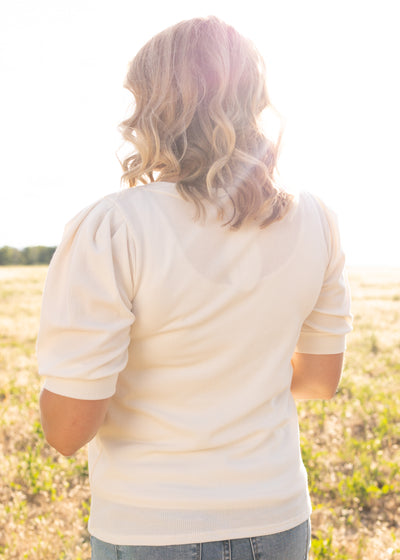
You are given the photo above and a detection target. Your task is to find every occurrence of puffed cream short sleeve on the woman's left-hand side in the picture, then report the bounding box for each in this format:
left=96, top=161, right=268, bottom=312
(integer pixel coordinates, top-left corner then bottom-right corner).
left=37, top=198, right=135, bottom=400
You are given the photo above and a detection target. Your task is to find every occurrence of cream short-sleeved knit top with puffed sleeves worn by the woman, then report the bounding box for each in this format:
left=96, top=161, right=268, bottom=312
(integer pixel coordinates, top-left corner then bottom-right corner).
left=38, top=183, right=351, bottom=545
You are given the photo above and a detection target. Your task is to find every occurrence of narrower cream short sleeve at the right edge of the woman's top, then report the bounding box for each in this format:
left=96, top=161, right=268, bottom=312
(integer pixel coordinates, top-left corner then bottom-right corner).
left=296, top=201, right=352, bottom=354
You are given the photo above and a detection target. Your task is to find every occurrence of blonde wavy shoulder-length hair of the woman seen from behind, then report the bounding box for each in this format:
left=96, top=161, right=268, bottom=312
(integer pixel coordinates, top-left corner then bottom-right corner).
left=120, top=16, right=292, bottom=228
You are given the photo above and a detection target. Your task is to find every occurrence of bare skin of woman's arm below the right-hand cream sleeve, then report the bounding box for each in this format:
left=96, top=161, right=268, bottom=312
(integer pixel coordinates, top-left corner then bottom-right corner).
left=291, top=352, right=343, bottom=399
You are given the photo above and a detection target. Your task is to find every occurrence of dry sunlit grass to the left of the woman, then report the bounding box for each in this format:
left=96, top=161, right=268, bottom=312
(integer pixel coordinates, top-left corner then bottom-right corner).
left=0, top=267, right=90, bottom=560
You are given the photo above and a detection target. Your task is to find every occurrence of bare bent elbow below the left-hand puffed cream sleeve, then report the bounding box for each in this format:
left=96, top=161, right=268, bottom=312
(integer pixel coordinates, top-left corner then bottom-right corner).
left=40, top=389, right=110, bottom=456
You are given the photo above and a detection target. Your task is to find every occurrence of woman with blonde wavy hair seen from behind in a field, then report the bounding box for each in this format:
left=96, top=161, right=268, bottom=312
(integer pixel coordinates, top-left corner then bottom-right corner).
left=38, top=17, right=351, bottom=560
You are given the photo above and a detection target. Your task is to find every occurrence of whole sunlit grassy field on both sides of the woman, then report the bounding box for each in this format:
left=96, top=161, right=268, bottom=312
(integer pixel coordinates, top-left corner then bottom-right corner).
left=0, top=267, right=400, bottom=560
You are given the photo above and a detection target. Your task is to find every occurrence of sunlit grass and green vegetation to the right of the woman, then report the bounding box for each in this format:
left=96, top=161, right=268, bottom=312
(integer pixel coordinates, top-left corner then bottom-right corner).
left=298, top=269, right=400, bottom=560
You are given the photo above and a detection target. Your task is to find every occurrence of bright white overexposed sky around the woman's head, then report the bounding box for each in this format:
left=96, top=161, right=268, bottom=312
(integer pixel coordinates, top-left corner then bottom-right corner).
left=0, top=0, right=400, bottom=266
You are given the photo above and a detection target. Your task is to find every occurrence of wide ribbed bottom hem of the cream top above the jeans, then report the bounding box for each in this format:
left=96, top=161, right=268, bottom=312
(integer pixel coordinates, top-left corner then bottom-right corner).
left=89, top=488, right=311, bottom=546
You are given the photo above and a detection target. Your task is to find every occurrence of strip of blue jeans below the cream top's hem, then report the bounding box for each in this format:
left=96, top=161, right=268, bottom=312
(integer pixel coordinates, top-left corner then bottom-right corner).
left=91, top=521, right=311, bottom=560
